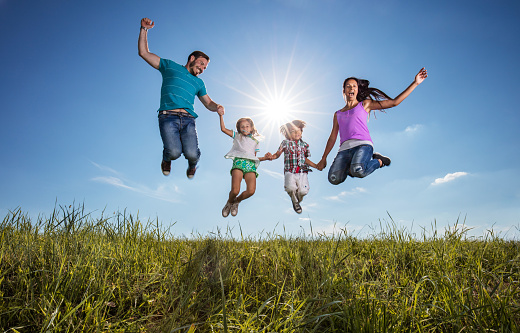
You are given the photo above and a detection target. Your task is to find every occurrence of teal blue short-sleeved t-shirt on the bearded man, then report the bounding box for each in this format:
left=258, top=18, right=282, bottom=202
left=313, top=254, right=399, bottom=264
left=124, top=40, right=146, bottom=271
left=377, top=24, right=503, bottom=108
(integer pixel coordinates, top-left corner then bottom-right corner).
left=159, top=58, right=207, bottom=118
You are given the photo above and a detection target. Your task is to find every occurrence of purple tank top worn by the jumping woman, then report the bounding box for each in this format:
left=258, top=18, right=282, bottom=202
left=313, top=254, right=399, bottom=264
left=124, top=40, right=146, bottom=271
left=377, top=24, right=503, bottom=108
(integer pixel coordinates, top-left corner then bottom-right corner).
left=336, top=102, right=372, bottom=145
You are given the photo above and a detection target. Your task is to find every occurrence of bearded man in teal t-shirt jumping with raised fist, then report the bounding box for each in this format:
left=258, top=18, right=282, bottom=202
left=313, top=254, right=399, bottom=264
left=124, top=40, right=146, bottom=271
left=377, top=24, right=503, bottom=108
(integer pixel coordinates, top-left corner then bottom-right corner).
left=138, top=18, right=224, bottom=179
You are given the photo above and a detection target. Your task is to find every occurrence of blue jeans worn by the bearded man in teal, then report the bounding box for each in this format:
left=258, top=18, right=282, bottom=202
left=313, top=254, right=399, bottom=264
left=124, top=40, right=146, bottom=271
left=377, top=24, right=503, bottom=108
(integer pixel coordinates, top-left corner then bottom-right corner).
left=159, top=114, right=200, bottom=168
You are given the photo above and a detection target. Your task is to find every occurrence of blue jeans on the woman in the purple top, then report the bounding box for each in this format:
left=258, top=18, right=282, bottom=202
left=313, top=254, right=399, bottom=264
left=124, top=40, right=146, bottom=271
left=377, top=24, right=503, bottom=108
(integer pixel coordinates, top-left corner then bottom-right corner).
left=329, top=145, right=379, bottom=185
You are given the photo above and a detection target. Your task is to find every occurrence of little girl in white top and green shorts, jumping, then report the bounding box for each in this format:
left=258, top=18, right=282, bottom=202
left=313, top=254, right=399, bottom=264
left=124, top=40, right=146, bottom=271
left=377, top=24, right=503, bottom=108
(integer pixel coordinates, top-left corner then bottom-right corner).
left=219, top=114, right=271, bottom=217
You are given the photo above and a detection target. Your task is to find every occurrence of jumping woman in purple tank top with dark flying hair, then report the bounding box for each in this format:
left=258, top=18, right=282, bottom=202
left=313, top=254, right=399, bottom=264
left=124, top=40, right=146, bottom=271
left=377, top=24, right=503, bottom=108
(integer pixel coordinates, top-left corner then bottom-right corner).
left=318, top=67, right=428, bottom=185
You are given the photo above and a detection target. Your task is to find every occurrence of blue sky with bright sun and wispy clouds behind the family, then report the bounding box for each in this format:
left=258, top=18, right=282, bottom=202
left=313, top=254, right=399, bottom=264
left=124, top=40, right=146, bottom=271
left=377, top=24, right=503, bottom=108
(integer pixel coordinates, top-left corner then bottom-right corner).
left=0, top=0, right=520, bottom=236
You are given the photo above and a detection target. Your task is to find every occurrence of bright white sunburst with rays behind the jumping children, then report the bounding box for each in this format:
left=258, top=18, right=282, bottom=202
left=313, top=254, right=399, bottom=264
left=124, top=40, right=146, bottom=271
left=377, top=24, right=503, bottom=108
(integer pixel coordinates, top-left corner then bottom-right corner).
left=212, top=32, right=330, bottom=146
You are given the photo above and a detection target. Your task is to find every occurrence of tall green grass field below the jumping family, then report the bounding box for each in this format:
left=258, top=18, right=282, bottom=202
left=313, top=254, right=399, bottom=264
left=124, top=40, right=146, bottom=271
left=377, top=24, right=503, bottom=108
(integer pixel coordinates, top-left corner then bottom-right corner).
left=0, top=207, right=520, bottom=332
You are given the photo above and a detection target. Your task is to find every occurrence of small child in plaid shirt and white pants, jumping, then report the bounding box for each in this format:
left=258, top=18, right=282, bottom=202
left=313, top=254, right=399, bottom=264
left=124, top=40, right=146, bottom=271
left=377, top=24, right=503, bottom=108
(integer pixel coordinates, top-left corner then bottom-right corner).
left=271, top=120, right=317, bottom=214
